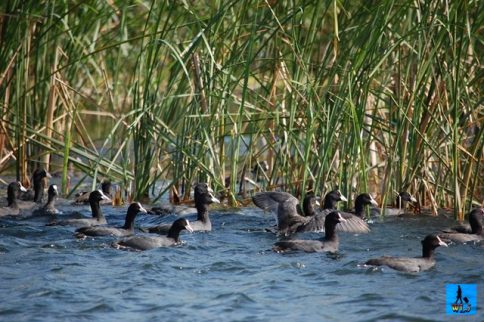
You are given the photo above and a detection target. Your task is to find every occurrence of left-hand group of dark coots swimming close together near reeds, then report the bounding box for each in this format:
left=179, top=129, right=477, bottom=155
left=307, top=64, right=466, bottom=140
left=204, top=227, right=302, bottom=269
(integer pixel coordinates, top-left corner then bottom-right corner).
left=0, top=174, right=220, bottom=250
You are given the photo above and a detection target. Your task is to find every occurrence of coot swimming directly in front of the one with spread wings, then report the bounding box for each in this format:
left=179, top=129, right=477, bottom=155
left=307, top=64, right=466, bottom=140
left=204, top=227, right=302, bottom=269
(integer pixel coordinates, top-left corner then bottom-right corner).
left=272, top=211, right=346, bottom=253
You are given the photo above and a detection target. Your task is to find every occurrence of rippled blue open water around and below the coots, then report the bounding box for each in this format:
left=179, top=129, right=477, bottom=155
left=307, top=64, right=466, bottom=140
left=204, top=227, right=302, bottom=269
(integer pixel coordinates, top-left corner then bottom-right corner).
left=0, top=200, right=484, bottom=321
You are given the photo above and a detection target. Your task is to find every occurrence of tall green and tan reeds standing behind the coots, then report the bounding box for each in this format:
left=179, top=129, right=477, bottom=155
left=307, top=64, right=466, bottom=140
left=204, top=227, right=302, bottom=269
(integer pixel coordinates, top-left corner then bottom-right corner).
left=0, top=0, right=484, bottom=217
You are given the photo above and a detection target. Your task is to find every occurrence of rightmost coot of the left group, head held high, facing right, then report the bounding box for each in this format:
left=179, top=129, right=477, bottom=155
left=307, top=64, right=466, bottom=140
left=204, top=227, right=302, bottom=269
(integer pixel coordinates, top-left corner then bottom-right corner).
left=142, top=183, right=220, bottom=234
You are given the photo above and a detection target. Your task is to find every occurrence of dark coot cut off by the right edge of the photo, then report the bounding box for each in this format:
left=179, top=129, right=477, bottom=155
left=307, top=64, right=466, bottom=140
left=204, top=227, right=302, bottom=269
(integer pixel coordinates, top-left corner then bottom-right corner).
left=438, top=208, right=484, bottom=243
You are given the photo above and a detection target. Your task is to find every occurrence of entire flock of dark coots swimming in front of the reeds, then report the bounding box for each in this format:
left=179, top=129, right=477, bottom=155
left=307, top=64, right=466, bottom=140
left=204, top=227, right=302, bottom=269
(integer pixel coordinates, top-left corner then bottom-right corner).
left=0, top=169, right=484, bottom=272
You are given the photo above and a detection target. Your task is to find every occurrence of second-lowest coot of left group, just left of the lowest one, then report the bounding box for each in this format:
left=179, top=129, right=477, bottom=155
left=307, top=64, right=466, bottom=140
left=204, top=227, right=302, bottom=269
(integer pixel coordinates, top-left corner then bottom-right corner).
left=74, top=202, right=147, bottom=238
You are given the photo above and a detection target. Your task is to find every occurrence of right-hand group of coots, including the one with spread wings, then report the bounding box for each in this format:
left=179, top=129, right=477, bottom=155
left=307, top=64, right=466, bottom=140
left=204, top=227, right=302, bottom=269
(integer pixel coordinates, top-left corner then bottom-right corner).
left=252, top=190, right=484, bottom=272
